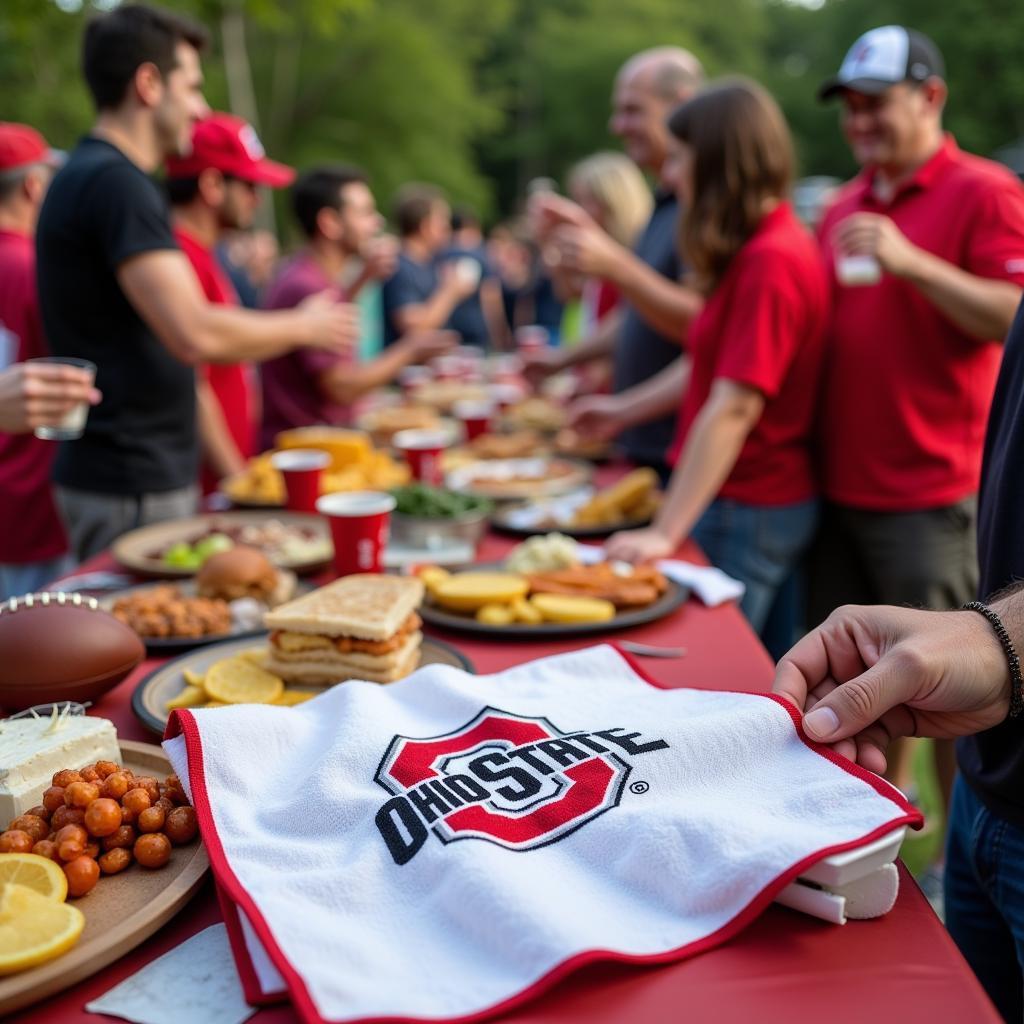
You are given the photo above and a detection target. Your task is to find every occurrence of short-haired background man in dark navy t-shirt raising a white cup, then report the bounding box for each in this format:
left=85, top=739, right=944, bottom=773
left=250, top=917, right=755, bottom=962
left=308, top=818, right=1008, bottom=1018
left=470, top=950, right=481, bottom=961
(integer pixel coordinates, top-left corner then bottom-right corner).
left=381, top=184, right=478, bottom=345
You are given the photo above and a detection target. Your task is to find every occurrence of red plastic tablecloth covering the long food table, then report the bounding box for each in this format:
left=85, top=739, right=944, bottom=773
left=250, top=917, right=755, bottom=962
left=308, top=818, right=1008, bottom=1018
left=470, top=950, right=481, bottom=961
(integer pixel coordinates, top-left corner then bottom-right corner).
left=9, top=536, right=1000, bottom=1024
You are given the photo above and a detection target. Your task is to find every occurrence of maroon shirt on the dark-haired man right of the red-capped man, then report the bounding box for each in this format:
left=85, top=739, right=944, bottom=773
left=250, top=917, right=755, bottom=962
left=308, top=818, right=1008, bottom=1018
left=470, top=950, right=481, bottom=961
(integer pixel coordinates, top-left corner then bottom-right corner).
left=260, top=253, right=353, bottom=450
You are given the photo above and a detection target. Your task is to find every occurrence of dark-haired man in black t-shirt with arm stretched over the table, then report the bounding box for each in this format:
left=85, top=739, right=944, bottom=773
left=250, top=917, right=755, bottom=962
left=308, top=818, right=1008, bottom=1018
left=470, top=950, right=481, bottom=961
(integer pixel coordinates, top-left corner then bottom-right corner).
left=37, top=5, right=357, bottom=558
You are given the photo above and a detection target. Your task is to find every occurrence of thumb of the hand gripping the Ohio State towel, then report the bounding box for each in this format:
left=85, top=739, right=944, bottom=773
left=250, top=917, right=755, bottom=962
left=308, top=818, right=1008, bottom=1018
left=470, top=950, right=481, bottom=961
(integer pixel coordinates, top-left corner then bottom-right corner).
left=804, top=652, right=922, bottom=742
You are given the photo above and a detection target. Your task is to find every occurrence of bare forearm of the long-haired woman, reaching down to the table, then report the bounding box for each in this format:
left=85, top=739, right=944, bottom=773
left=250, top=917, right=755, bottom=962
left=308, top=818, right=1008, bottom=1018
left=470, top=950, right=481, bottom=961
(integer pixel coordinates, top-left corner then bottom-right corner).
left=654, top=391, right=753, bottom=544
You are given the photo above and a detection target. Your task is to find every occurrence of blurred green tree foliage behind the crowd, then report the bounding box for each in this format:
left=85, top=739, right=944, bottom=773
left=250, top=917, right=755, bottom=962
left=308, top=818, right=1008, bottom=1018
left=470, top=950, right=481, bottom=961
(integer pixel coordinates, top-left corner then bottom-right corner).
left=0, top=0, right=1024, bottom=228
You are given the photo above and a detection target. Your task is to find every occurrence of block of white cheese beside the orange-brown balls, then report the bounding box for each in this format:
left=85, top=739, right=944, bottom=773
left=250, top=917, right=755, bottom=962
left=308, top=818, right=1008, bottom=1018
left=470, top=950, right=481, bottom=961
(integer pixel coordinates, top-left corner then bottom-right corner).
left=0, top=714, right=121, bottom=830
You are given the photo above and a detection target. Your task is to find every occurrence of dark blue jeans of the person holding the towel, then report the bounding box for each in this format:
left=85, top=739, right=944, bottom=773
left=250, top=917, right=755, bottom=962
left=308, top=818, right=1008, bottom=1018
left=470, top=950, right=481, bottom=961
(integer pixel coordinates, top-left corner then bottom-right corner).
left=945, top=778, right=1024, bottom=1024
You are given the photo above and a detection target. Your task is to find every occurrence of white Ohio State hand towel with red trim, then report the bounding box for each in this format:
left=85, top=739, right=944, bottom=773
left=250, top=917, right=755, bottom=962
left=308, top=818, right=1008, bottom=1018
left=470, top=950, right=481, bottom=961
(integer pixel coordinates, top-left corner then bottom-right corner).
left=164, top=646, right=921, bottom=1022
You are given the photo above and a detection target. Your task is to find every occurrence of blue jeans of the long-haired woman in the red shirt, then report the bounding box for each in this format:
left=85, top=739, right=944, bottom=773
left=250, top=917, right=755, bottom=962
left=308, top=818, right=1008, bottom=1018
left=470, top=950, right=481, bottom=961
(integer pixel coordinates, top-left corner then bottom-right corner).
left=691, top=498, right=818, bottom=634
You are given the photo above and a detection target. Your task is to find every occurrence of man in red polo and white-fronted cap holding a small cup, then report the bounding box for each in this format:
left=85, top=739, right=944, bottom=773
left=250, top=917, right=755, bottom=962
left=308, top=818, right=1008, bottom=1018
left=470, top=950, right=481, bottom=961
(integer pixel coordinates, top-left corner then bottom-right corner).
left=811, top=26, right=1024, bottom=806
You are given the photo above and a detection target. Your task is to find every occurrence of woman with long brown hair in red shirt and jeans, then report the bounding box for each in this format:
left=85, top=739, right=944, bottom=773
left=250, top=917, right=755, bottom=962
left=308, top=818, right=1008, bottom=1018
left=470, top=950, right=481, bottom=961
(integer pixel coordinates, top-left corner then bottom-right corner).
left=607, top=79, right=828, bottom=631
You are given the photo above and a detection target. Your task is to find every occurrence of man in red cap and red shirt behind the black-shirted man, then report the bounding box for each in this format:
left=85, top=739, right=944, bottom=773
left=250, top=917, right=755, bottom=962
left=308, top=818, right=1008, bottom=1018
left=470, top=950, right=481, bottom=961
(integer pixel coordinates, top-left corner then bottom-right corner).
left=167, top=114, right=295, bottom=494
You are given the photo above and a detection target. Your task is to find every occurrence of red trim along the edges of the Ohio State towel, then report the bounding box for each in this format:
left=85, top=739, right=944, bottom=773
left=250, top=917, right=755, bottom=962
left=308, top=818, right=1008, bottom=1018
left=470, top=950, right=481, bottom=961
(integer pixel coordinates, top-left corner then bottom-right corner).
left=164, top=644, right=924, bottom=1024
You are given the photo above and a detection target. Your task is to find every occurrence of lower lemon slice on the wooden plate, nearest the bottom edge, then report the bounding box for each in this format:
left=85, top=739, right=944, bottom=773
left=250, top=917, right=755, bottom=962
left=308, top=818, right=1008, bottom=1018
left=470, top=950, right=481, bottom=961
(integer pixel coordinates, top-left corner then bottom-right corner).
left=0, top=880, right=85, bottom=975
